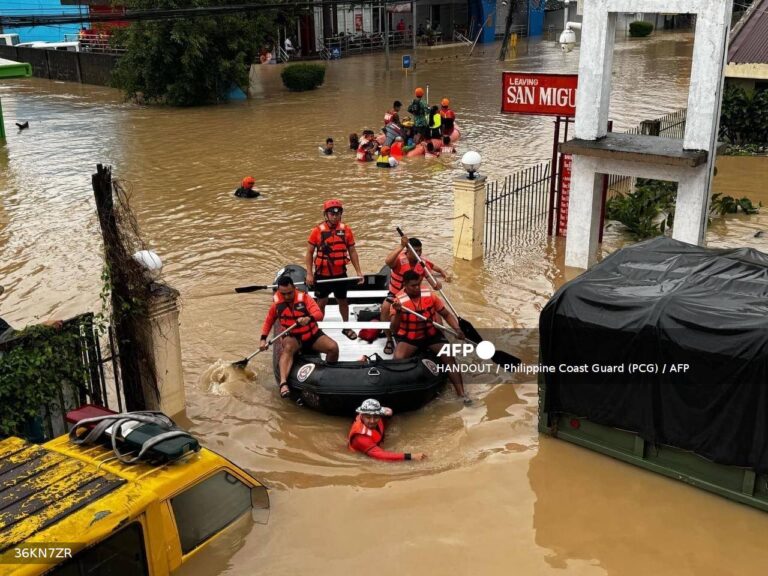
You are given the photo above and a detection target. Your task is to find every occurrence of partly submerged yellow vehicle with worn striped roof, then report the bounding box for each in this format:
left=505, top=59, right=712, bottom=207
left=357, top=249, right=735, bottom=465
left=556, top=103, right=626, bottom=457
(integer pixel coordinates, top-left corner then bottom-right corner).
left=0, top=412, right=269, bottom=576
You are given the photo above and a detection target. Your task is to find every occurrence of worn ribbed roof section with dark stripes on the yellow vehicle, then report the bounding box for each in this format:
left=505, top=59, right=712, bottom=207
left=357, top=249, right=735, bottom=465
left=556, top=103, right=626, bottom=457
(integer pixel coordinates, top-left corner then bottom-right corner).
left=0, top=438, right=125, bottom=552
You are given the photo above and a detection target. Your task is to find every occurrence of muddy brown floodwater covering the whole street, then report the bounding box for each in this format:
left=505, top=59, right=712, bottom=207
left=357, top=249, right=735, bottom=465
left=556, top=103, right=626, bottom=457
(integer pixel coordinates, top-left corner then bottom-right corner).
left=0, top=33, right=768, bottom=576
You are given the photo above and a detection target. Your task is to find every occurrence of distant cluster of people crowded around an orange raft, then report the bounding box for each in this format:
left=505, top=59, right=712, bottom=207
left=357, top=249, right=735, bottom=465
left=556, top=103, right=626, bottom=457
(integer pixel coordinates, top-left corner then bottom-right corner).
left=349, top=88, right=459, bottom=168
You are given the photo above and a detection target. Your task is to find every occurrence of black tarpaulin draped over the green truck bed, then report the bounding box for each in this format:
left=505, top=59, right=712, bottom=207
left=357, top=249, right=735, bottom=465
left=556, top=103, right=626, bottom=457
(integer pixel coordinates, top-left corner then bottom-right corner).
left=539, top=238, right=768, bottom=472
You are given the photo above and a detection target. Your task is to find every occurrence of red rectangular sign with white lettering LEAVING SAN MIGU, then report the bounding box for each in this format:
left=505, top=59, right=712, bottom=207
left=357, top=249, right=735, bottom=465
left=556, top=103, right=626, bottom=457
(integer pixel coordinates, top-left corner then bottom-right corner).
left=501, top=72, right=579, bottom=116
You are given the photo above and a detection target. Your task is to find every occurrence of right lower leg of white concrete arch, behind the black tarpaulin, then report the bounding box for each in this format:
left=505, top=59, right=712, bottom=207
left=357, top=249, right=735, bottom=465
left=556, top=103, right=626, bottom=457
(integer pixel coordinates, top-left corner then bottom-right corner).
left=672, top=163, right=710, bottom=246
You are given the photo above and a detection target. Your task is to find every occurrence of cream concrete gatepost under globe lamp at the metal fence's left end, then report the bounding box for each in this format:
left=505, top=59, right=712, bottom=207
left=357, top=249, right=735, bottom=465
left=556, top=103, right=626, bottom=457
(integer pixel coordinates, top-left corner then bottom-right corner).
left=453, top=176, right=485, bottom=260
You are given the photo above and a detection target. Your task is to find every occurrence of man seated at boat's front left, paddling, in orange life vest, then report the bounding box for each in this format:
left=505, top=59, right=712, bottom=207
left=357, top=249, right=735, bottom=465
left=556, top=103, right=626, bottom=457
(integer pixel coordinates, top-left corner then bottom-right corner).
left=259, top=276, right=339, bottom=398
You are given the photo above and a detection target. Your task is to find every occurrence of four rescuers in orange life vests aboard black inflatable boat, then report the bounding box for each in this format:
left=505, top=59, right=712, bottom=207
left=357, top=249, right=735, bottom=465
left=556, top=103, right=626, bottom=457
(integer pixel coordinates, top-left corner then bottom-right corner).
left=260, top=198, right=468, bottom=414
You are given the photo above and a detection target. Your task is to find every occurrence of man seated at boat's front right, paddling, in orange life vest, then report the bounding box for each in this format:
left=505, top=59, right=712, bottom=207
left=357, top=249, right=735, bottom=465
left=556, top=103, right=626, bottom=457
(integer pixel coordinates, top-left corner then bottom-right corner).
left=390, top=270, right=471, bottom=404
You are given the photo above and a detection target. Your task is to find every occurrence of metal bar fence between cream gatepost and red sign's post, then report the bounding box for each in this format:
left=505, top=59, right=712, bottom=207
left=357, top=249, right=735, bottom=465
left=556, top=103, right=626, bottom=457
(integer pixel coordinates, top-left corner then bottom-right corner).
left=483, top=161, right=552, bottom=254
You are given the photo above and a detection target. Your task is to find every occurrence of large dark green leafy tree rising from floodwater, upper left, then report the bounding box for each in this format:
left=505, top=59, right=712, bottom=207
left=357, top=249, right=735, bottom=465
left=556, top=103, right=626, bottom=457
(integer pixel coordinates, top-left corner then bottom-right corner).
left=112, top=0, right=290, bottom=106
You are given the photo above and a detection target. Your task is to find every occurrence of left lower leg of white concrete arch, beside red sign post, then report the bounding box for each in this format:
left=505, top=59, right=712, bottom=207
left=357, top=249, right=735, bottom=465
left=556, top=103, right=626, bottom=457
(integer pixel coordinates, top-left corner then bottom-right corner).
left=565, top=155, right=603, bottom=268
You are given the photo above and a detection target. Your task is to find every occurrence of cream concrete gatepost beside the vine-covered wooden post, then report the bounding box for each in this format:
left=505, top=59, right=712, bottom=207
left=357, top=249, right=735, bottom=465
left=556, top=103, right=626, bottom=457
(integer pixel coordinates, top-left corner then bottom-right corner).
left=145, top=284, right=186, bottom=416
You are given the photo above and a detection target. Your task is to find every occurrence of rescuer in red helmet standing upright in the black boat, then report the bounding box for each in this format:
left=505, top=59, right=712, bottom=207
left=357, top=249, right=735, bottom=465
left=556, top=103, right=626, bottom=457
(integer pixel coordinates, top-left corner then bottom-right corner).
left=304, top=198, right=365, bottom=340
